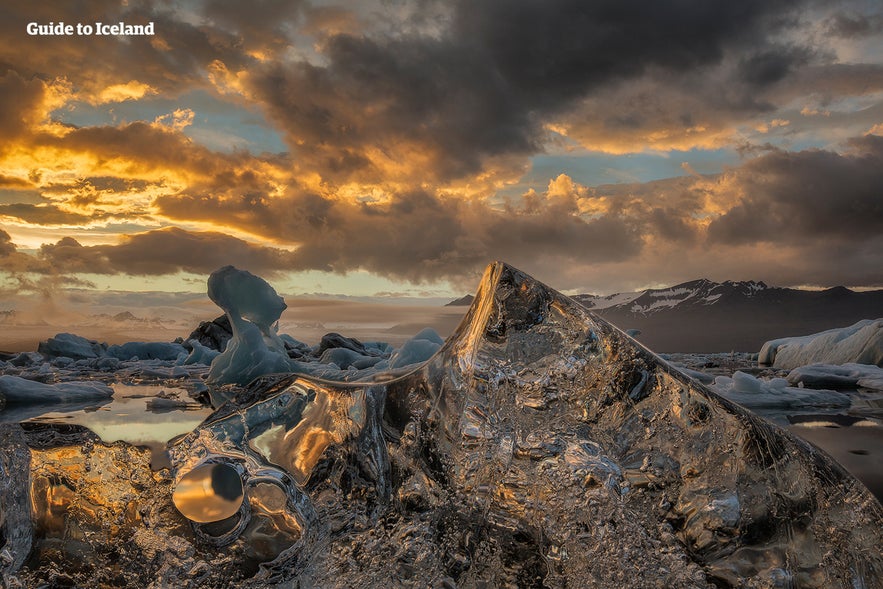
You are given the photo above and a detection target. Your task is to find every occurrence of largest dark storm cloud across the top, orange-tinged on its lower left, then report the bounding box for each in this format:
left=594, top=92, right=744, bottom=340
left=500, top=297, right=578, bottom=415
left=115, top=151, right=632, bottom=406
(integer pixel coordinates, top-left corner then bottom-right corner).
left=250, top=0, right=812, bottom=179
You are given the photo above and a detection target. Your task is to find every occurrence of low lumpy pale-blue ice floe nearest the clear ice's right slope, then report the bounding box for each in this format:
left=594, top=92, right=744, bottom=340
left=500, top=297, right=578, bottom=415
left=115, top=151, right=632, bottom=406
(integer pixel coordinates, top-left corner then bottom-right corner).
left=711, top=371, right=850, bottom=409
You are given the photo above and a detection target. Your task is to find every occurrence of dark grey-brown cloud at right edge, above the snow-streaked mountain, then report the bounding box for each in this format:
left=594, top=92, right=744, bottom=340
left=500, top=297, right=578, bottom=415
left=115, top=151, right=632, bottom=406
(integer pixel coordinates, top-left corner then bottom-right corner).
left=709, top=135, right=883, bottom=244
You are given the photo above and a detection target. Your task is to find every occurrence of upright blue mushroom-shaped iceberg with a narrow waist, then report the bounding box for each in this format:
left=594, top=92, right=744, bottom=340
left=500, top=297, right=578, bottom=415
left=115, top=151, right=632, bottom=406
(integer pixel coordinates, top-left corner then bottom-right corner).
left=208, top=266, right=291, bottom=384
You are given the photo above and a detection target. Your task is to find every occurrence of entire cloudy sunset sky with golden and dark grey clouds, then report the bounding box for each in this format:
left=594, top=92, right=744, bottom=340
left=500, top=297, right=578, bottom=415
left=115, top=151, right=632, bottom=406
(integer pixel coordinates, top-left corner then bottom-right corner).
left=0, top=0, right=883, bottom=307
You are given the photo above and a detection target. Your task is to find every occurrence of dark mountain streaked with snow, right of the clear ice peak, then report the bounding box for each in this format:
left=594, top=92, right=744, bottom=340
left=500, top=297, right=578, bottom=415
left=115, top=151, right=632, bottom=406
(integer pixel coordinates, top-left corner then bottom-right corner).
left=572, top=279, right=883, bottom=352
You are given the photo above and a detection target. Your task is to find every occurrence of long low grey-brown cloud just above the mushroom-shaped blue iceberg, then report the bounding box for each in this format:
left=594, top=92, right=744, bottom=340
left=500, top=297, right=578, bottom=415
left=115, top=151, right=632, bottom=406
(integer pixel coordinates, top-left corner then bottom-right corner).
left=38, top=228, right=300, bottom=275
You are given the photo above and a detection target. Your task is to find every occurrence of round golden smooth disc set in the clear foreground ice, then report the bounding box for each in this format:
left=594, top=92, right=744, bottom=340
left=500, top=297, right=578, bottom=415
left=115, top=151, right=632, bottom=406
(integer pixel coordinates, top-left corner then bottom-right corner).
left=172, top=463, right=243, bottom=523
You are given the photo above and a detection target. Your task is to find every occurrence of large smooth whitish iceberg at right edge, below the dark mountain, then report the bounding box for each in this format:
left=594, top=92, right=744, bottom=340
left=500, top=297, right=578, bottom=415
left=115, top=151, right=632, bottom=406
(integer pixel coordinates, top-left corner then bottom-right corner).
left=757, top=319, right=883, bottom=370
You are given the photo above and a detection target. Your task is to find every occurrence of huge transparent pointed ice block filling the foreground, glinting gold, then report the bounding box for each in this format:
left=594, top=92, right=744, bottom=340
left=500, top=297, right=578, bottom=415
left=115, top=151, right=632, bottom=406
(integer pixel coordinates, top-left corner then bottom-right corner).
left=0, top=263, right=883, bottom=588
